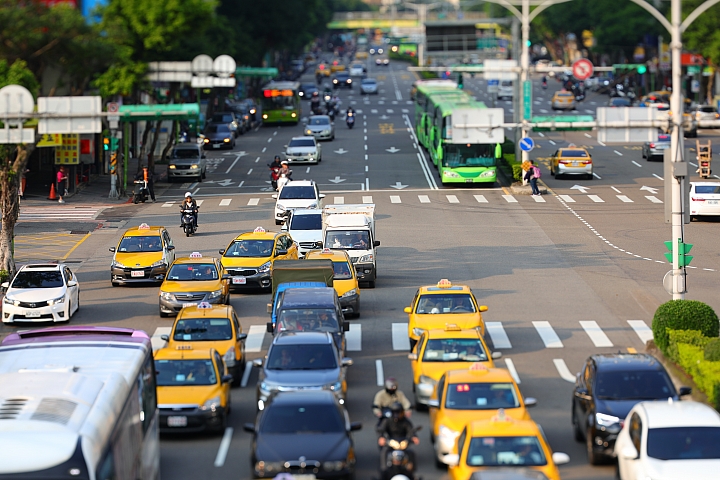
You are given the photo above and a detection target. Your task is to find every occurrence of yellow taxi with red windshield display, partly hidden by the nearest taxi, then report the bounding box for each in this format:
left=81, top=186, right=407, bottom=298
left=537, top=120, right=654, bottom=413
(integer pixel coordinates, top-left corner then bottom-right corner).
left=428, top=363, right=537, bottom=464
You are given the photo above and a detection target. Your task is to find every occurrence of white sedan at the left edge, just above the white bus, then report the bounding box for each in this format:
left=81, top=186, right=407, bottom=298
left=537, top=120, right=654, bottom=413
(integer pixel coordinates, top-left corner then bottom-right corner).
left=2, top=263, right=80, bottom=323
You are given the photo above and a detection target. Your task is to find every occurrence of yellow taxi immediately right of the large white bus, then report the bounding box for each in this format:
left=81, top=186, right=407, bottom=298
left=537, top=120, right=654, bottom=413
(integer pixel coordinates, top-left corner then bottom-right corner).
left=154, top=345, right=232, bottom=432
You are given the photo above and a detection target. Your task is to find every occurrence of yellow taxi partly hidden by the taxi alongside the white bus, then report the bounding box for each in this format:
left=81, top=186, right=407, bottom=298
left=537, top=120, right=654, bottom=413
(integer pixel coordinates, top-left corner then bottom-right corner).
left=161, top=302, right=247, bottom=386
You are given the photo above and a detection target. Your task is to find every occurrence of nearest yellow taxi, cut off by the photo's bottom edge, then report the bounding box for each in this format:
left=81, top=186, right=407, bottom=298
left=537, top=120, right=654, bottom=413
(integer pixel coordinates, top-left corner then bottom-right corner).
left=445, top=409, right=570, bottom=480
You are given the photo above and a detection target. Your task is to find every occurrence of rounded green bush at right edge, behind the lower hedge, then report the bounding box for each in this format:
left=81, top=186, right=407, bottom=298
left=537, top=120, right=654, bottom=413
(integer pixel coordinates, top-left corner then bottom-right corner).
left=652, top=300, right=720, bottom=355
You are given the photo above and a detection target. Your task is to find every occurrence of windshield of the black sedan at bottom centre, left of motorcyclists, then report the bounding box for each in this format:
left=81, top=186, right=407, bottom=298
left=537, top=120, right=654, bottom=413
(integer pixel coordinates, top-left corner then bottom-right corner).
left=260, top=404, right=345, bottom=435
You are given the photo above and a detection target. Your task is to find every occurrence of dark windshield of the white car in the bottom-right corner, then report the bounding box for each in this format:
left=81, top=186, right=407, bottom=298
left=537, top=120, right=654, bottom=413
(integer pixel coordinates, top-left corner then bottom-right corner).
left=647, top=427, right=720, bottom=460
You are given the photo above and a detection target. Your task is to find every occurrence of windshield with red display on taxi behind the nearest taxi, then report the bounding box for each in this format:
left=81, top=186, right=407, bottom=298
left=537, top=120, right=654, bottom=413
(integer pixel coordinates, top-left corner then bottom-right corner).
left=445, top=383, right=520, bottom=410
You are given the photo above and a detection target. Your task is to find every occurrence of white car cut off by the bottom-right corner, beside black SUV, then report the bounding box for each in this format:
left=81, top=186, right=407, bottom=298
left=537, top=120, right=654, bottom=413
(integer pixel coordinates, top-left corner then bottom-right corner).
left=615, top=400, right=720, bottom=480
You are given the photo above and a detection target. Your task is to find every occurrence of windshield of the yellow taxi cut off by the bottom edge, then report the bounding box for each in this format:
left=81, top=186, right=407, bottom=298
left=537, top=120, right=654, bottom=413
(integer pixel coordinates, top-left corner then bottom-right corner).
left=467, top=437, right=547, bottom=467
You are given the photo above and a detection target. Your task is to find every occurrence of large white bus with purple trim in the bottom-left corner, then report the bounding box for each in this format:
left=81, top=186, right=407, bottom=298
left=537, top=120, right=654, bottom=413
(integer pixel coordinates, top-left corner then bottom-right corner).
left=0, top=326, right=160, bottom=480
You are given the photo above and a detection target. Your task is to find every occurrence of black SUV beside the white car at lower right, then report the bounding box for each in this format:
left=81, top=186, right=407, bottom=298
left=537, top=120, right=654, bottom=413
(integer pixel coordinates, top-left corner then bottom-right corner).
left=571, top=353, right=690, bottom=465
